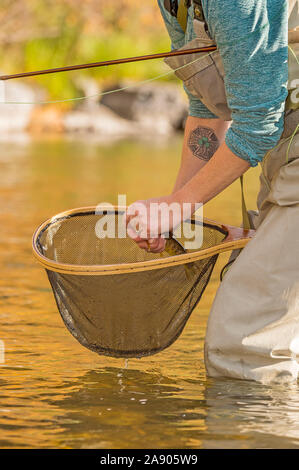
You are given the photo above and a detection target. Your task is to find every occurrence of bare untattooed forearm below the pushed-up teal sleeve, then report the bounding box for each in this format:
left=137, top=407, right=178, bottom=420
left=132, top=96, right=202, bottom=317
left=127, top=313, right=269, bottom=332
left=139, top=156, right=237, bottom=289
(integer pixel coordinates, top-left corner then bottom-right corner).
left=173, top=143, right=250, bottom=204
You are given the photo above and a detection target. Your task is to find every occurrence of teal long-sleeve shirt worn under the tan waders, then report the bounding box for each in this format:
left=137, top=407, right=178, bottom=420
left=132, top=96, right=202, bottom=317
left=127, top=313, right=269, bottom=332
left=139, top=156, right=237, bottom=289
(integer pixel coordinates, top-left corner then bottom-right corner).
left=158, top=0, right=288, bottom=166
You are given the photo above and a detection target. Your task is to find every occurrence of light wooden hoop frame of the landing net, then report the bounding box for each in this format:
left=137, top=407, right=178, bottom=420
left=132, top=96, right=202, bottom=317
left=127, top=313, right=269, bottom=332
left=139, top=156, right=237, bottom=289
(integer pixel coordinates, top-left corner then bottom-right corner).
left=32, top=206, right=255, bottom=276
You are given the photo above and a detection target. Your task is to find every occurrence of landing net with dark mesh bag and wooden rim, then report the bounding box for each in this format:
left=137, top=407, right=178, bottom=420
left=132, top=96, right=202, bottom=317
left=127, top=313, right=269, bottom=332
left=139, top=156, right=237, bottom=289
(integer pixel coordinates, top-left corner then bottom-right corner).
left=33, top=208, right=253, bottom=357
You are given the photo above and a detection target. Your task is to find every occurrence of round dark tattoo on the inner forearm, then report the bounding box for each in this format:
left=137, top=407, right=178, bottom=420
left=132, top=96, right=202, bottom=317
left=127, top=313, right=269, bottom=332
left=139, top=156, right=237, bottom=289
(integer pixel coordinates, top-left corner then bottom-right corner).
left=188, top=126, right=219, bottom=161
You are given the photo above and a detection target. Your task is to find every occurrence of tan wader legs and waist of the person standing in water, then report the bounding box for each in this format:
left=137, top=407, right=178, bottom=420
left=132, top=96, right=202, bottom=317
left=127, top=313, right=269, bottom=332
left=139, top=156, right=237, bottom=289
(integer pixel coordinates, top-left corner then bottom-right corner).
left=205, top=111, right=299, bottom=383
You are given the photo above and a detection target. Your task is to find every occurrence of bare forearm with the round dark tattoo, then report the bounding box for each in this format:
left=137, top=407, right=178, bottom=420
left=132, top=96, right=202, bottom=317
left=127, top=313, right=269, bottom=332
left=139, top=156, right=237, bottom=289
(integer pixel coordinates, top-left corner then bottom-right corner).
left=173, top=116, right=230, bottom=193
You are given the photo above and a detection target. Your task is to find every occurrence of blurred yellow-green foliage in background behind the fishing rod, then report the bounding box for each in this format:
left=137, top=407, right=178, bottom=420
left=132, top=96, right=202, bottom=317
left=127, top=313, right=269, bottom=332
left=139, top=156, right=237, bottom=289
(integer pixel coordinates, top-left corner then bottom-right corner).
left=0, top=0, right=170, bottom=99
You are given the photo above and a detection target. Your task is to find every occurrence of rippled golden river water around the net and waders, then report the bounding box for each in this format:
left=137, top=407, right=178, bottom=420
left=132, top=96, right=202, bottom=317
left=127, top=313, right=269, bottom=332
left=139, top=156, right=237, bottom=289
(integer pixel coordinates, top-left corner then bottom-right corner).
left=0, top=136, right=299, bottom=449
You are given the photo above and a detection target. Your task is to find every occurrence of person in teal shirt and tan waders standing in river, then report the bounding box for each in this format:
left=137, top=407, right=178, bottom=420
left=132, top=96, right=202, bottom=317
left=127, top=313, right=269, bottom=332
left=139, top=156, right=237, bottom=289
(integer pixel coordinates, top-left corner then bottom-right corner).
left=127, top=0, right=299, bottom=383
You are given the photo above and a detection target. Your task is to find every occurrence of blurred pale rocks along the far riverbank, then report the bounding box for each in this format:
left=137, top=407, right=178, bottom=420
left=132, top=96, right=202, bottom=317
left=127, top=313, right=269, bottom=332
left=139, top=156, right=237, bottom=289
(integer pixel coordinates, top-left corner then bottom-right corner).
left=0, top=78, right=188, bottom=140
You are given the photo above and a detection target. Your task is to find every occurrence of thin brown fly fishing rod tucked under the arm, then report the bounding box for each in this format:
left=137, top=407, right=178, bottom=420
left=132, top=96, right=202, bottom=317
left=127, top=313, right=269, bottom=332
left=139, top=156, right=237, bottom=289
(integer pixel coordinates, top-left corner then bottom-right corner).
left=0, top=46, right=217, bottom=80
